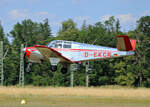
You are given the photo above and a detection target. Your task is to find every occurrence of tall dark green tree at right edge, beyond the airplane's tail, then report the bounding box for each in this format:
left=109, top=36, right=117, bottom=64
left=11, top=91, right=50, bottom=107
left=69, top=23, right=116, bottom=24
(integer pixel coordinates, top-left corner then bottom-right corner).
left=129, top=16, right=150, bottom=87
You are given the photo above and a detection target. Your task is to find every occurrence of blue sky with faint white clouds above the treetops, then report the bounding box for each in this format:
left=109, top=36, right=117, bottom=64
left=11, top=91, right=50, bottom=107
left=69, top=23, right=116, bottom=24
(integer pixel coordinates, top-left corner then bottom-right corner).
left=0, top=0, right=150, bottom=35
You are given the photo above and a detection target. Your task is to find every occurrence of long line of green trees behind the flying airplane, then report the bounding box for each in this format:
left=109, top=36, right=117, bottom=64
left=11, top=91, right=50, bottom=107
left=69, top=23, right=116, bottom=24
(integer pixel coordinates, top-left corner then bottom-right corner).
left=0, top=16, right=150, bottom=87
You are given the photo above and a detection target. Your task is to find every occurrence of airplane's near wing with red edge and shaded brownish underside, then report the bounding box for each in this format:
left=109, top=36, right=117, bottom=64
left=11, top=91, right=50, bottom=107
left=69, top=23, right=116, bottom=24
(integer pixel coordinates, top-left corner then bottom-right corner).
left=34, top=45, right=74, bottom=63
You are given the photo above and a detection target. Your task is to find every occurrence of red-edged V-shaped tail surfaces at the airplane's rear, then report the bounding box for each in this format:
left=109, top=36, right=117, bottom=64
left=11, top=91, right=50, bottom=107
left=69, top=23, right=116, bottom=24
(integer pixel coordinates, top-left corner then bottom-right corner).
left=117, top=35, right=136, bottom=51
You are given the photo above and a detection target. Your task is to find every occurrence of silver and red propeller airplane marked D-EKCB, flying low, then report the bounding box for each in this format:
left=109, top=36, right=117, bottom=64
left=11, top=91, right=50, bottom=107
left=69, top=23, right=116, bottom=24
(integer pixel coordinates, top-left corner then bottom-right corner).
left=23, top=35, right=136, bottom=74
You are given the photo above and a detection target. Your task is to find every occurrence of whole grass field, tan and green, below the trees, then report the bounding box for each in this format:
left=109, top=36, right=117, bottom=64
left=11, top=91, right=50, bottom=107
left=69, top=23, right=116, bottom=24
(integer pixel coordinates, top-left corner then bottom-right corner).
left=0, top=87, right=150, bottom=107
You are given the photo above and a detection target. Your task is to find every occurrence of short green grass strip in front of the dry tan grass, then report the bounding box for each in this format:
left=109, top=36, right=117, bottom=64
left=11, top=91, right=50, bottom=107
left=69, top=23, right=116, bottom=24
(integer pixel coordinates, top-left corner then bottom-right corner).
left=0, top=95, right=150, bottom=107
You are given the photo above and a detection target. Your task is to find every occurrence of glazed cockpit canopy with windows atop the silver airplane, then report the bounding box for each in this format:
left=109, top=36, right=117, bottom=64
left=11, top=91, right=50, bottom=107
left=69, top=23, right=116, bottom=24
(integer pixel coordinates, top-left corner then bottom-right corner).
left=48, top=40, right=72, bottom=48
